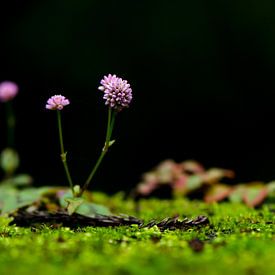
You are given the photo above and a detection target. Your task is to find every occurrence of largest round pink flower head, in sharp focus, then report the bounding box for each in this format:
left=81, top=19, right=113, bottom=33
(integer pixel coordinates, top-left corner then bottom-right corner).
left=98, top=74, right=132, bottom=111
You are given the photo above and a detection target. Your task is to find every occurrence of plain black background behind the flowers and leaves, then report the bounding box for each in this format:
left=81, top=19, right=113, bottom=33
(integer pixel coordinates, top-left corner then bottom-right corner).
left=0, top=0, right=275, bottom=192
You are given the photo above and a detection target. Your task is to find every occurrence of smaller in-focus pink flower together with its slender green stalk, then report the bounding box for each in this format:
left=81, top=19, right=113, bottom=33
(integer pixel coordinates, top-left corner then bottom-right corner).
left=46, top=95, right=75, bottom=196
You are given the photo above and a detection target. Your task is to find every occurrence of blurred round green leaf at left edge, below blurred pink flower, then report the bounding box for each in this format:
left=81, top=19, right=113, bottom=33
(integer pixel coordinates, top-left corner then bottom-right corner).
left=0, top=148, right=19, bottom=175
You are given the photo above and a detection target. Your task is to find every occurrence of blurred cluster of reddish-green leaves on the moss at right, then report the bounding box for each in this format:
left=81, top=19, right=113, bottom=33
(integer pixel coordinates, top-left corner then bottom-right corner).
left=135, top=160, right=275, bottom=207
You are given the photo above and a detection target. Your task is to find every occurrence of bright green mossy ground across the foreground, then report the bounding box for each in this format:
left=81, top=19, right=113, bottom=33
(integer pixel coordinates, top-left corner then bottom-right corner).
left=0, top=194, right=275, bottom=275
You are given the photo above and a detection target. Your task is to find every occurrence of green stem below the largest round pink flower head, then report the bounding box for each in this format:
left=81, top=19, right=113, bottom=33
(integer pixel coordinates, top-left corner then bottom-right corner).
left=79, top=108, right=116, bottom=197
